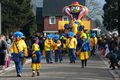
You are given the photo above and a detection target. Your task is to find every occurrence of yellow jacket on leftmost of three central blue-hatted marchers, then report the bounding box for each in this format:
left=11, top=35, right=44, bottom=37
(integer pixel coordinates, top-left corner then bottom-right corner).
left=44, top=39, right=54, bottom=51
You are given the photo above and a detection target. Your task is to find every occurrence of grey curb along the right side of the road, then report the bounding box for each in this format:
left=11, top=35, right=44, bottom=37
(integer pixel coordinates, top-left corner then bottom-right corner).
left=98, top=53, right=120, bottom=80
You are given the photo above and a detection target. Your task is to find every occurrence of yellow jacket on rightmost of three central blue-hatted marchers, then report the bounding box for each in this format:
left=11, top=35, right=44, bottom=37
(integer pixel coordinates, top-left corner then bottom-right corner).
left=66, top=37, right=77, bottom=49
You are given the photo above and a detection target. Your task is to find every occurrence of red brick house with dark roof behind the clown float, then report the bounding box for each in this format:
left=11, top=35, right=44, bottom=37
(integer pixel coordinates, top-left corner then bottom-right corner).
left=42, top=0, right=85, bottom=33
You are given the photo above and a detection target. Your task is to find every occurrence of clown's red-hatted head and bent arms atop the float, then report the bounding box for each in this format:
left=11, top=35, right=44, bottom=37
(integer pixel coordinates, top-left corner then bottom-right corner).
left=63, top=2, right=89, bottom=20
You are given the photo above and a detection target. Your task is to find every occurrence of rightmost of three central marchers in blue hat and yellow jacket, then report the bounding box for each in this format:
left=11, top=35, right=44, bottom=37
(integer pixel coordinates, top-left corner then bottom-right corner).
left=66, top=32, right=77, bottom=63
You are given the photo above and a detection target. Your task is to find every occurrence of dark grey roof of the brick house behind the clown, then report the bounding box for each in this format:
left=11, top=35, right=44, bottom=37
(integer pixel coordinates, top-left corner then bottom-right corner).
left=43, top=0, right=85, bottom=16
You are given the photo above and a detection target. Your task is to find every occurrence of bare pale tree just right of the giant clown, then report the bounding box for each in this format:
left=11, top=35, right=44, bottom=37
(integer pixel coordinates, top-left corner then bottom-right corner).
left=86, top=0, right=104, bottom=28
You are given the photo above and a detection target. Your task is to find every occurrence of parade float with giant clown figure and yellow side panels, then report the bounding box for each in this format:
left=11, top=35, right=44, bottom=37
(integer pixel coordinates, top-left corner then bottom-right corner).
left=58, top=1, right=90, bottom=35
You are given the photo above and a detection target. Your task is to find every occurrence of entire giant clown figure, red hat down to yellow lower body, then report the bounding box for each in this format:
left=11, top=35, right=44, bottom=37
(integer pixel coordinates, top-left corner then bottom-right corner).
left=63, top=1, right=89, bottom=35
